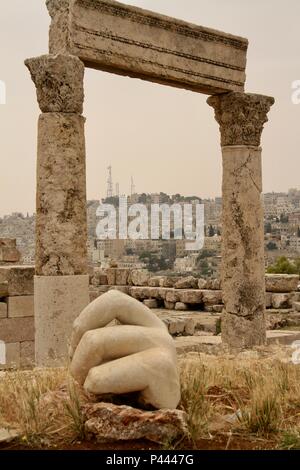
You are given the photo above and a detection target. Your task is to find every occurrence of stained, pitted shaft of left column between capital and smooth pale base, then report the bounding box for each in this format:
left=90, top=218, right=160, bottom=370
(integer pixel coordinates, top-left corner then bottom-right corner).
left=36, top=113, right=88, bottom=276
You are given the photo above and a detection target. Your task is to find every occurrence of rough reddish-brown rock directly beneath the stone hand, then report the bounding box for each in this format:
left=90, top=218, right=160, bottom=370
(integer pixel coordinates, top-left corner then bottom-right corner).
left=83, top=403, right=188, bottom=443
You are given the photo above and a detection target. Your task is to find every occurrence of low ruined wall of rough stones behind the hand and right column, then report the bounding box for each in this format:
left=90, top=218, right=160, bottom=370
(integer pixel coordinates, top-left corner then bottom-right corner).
left=90, top=268, right=300, bottom=336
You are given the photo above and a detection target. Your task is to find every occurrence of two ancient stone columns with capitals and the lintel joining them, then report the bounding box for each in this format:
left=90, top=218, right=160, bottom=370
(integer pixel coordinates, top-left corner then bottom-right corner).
left=25, top=0, right=276, bottom=365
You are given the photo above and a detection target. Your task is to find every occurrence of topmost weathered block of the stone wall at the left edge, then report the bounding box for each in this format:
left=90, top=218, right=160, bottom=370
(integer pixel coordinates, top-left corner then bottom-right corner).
left=0, top=265, right=34, bottom=297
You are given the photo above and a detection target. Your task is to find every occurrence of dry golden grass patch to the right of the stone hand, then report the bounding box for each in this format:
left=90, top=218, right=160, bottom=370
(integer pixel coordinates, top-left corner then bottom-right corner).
left=180, top=349, right=300, bottom=447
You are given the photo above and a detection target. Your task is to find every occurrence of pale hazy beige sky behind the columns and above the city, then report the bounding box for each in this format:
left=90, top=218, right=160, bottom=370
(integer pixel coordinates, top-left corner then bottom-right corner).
left=0, top=0, right=300, bottom=216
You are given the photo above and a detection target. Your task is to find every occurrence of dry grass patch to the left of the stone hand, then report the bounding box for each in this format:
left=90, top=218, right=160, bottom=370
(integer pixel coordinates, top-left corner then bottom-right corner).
left=0, top=368, right=86, bottom=447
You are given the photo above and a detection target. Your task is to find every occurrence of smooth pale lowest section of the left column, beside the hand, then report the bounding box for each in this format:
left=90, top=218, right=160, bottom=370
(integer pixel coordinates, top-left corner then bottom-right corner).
left=34, top=275, right=89, bottom=366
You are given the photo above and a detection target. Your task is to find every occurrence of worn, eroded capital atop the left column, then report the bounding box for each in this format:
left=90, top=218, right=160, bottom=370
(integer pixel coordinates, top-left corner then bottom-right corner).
left=25, top=54, right=84, bottom=114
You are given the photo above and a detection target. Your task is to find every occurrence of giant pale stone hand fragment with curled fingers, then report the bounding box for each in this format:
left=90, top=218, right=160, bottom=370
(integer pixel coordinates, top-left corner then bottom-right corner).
left=70, top=290, right=180, bottom=409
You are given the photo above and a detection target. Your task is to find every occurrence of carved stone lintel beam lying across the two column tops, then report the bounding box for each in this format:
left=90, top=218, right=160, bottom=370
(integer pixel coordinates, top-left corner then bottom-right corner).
left=47, top=0, right=248, bottom=94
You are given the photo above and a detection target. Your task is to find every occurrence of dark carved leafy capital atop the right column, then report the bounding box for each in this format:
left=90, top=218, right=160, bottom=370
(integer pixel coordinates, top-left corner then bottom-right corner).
left=207, top=92, right=275, bottom=147
